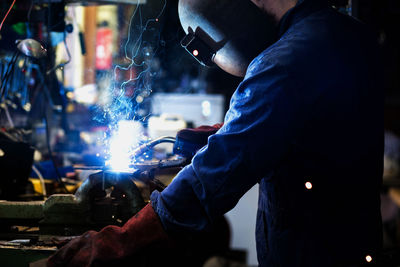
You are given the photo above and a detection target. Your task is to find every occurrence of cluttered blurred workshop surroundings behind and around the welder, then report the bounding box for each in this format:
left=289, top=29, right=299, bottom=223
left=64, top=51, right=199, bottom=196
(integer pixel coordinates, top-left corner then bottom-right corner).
left=0, top=0, right=400, bottom=266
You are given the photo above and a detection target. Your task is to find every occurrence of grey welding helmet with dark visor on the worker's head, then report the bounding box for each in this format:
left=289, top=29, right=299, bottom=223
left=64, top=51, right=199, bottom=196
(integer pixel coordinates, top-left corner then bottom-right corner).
left=178, top=0, right=276, bottom=77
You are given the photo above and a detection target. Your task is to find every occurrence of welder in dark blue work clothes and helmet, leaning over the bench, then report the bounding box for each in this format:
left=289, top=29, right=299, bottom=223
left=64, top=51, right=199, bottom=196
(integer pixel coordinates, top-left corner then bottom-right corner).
left=48, top=0, right=383, bottom=267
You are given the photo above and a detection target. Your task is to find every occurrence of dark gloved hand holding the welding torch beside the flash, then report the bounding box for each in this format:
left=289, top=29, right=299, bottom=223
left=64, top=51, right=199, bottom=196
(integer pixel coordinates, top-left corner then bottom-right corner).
left=174, top=123, right=223, bottom=158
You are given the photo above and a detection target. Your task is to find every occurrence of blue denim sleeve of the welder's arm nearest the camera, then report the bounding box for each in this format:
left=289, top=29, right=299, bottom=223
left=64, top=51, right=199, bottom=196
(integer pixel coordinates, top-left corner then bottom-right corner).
left=151, top=54, right=315, bottom=232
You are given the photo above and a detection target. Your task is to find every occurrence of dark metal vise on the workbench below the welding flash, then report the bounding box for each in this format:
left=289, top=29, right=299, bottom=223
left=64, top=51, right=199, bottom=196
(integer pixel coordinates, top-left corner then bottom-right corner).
left=40, top=171, right=146, bottom=235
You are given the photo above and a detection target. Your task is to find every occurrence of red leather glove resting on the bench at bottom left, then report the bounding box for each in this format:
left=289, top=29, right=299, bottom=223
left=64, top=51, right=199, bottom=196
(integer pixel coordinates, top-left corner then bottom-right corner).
left=47, top=204, right=172, bottom=267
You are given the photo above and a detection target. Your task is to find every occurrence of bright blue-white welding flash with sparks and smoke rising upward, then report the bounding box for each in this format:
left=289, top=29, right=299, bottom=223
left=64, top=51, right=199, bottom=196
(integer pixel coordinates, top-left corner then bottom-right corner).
left=95, top=0, right=167, bottom=171
